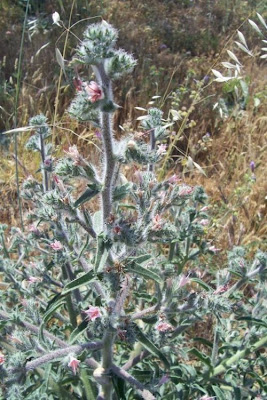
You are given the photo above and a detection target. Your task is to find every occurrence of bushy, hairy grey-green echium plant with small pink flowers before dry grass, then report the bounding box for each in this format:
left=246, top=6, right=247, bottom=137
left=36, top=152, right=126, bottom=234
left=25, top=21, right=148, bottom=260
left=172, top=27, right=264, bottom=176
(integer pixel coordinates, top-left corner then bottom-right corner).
left=0, top=22, right=267, bottom=400
